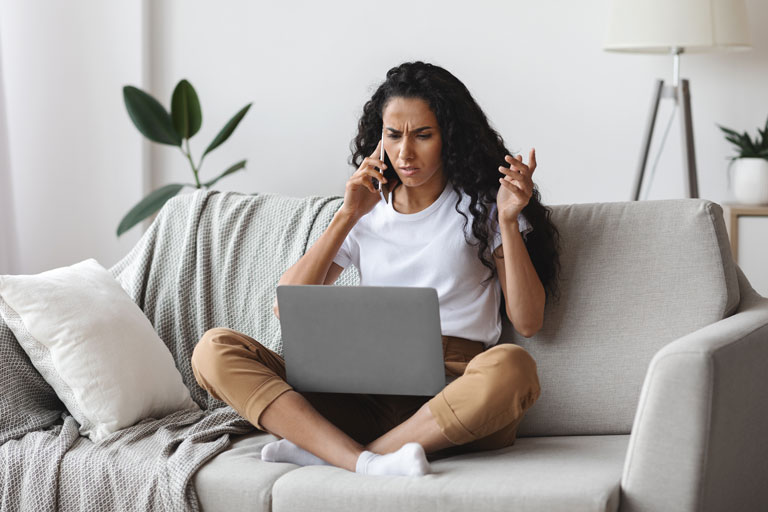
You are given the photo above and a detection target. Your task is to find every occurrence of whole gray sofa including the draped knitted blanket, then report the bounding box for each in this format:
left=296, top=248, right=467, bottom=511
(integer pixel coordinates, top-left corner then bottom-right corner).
left=0, top=190, right=768, bottom=512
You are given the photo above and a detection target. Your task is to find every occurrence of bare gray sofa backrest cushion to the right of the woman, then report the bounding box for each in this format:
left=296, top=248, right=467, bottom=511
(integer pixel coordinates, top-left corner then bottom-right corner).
left=510, top=199, right=739, bottom=437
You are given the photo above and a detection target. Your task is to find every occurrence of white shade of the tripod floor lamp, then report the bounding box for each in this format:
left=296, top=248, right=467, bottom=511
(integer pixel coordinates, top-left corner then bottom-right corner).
left=603, top=0, right=751, bottom=54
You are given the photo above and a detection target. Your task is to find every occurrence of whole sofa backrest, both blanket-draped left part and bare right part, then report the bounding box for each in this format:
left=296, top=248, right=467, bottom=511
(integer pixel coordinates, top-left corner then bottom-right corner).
left=110, top=190, right=739, bottom=437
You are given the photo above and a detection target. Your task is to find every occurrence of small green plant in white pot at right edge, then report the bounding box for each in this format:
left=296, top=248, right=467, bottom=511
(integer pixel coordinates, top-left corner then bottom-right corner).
left=717, top=115, right=768, bottom=204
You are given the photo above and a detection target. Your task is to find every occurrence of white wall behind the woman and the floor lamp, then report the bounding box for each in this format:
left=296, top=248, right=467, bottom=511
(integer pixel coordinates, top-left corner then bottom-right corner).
left=146, top=0, right=768, bottom=204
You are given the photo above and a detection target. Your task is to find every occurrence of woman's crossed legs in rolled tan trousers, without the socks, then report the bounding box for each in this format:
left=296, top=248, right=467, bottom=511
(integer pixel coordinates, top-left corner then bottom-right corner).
left=192, top=328, right=540, bottom=471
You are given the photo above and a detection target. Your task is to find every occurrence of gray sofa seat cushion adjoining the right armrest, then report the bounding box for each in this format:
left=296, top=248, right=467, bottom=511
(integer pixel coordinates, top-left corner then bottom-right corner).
left=264, top=436, right=629, bottom=512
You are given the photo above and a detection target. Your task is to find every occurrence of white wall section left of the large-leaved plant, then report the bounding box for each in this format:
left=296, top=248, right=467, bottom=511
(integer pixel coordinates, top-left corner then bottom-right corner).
left=0, top=0, right=142, bottom=273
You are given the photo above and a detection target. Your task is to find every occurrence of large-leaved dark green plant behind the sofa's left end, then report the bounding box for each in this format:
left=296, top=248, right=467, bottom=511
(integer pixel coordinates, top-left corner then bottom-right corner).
left=117, top=80, right=252, bottom=237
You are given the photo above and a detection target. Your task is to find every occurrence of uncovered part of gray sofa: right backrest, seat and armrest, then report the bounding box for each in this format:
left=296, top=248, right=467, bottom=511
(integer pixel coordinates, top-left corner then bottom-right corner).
left=194, top=194, right=768, bottom=512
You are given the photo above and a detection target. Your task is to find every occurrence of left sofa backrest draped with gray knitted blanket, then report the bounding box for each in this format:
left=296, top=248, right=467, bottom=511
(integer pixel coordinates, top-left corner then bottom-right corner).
left=110, top=190, right=357, bottom=408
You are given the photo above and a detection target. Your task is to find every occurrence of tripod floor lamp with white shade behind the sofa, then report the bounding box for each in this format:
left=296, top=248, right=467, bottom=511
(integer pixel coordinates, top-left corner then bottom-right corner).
left=603, top=0, right=751, bottom=201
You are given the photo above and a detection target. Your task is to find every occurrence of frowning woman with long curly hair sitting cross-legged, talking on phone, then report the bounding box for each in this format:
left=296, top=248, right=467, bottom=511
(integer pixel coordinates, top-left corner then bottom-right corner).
left=192, top=62, right=559, bottom=475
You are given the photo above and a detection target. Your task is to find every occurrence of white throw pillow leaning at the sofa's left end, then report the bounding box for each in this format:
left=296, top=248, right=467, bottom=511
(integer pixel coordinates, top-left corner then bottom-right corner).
left=0, top=259, right=199, bottom=442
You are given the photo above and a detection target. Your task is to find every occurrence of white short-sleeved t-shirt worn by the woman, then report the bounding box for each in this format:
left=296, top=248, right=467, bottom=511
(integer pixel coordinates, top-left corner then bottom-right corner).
left=333, top=183, right=533, bottom=348
